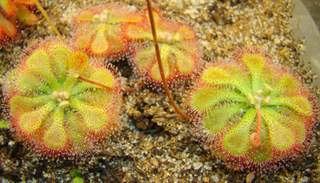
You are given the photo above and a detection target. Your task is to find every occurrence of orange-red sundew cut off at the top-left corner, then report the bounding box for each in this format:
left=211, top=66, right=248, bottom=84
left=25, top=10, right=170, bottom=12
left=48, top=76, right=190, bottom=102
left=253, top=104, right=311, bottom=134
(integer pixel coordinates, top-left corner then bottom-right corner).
left=0, top=0, right=38, bottom=40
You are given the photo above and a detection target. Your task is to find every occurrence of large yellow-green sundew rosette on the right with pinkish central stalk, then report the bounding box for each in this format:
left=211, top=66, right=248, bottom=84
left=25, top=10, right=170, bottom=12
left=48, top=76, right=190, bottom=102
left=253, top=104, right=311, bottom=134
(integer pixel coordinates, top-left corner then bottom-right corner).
left=190, top=49, right=316, bottom=169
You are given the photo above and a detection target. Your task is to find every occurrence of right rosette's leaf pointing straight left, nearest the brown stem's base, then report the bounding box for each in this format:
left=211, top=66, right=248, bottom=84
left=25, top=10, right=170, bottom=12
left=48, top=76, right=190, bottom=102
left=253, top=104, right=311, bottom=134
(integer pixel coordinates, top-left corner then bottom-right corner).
left=191, top=87, right=247, bottom=112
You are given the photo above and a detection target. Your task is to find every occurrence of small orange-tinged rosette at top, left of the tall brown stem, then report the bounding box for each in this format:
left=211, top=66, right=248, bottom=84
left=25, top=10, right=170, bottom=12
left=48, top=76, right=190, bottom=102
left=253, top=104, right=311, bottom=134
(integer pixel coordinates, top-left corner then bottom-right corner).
left=73, top=3, right=141, bottom=56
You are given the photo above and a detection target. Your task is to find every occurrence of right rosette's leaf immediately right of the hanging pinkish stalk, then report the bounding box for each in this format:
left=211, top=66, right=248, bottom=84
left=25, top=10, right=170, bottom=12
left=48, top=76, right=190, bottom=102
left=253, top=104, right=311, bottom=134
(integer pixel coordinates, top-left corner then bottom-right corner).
left=261, top=108, right=295, bottom=151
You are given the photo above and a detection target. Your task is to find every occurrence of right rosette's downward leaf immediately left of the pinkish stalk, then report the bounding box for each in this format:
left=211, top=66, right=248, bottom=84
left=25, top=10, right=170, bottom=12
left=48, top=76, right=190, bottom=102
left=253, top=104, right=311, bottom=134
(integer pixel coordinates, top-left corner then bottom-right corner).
left=223, top=109, right=256, bottom=156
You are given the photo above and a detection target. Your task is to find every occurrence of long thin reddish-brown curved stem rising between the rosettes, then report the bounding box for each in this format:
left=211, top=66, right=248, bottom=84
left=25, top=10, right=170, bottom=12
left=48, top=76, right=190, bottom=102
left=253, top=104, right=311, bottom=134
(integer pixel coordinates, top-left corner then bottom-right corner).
left=146, top=0, right=190, bottom=120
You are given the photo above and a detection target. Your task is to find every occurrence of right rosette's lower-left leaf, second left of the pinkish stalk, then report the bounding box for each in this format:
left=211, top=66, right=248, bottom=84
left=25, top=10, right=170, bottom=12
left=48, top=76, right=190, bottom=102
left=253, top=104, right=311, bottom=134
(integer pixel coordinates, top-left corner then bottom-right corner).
left=203, top=104, right=246, bottom=134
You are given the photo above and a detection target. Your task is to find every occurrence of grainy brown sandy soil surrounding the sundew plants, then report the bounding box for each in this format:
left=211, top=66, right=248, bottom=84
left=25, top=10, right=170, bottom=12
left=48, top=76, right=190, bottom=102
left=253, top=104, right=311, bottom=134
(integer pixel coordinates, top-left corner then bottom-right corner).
left=0, top=0, right=320, bottom=183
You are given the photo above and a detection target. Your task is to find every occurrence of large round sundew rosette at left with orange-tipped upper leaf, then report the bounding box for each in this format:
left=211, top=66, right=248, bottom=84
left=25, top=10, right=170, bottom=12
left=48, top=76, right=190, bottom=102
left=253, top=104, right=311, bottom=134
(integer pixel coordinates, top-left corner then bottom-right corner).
left=5, top=40, right=122, bottom=156
